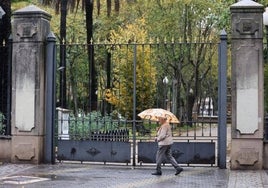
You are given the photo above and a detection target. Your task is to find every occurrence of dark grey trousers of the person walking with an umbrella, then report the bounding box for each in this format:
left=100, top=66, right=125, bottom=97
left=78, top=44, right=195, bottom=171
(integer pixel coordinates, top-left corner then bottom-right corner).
left=156, top=145, right=180, bottom=172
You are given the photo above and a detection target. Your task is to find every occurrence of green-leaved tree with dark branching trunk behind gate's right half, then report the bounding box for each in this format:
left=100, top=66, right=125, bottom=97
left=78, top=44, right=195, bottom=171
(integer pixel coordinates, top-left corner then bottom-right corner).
left=140, top=0, right=229, bottom=122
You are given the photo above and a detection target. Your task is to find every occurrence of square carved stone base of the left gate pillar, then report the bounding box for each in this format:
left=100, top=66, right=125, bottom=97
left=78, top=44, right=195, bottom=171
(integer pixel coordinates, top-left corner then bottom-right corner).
left=11, top=136, right=44, bottom=164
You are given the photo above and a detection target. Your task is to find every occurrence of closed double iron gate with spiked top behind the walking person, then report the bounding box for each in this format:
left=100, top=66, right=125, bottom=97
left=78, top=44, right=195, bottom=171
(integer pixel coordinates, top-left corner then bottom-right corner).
left=52, top=34, right=227, bottom=166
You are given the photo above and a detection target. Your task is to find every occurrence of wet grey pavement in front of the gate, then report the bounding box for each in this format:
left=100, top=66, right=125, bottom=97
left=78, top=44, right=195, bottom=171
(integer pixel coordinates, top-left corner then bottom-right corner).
left=0, top=163, right=268, bottom=188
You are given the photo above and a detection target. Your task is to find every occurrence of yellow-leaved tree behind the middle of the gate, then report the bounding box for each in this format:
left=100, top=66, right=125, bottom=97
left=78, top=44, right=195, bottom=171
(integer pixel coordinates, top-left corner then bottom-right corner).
left=106, top=18, right=156, bottom=118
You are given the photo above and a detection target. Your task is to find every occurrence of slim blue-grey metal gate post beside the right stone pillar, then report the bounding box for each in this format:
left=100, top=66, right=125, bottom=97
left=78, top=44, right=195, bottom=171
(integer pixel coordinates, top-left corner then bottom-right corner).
left=218, top=30, right=227, bottom=169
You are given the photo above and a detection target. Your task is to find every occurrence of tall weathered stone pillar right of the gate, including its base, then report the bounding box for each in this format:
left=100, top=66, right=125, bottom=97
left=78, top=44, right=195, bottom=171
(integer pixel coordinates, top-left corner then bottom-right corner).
left=230, top=0, right=264, bottom=169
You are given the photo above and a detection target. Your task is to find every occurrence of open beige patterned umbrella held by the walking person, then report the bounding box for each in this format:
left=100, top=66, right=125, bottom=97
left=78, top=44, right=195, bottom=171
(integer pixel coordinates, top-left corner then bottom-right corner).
left=138, top=108, right=180, bottom=123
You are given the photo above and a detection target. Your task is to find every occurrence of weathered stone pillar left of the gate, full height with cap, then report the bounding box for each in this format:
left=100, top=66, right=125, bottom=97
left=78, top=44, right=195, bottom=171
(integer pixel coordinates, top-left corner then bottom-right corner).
left=11, top=5, right=51, bottom=164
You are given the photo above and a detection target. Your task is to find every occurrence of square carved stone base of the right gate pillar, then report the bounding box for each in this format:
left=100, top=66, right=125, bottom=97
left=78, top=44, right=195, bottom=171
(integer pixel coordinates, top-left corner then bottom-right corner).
left=230, top=138, right=263, bottom=170
